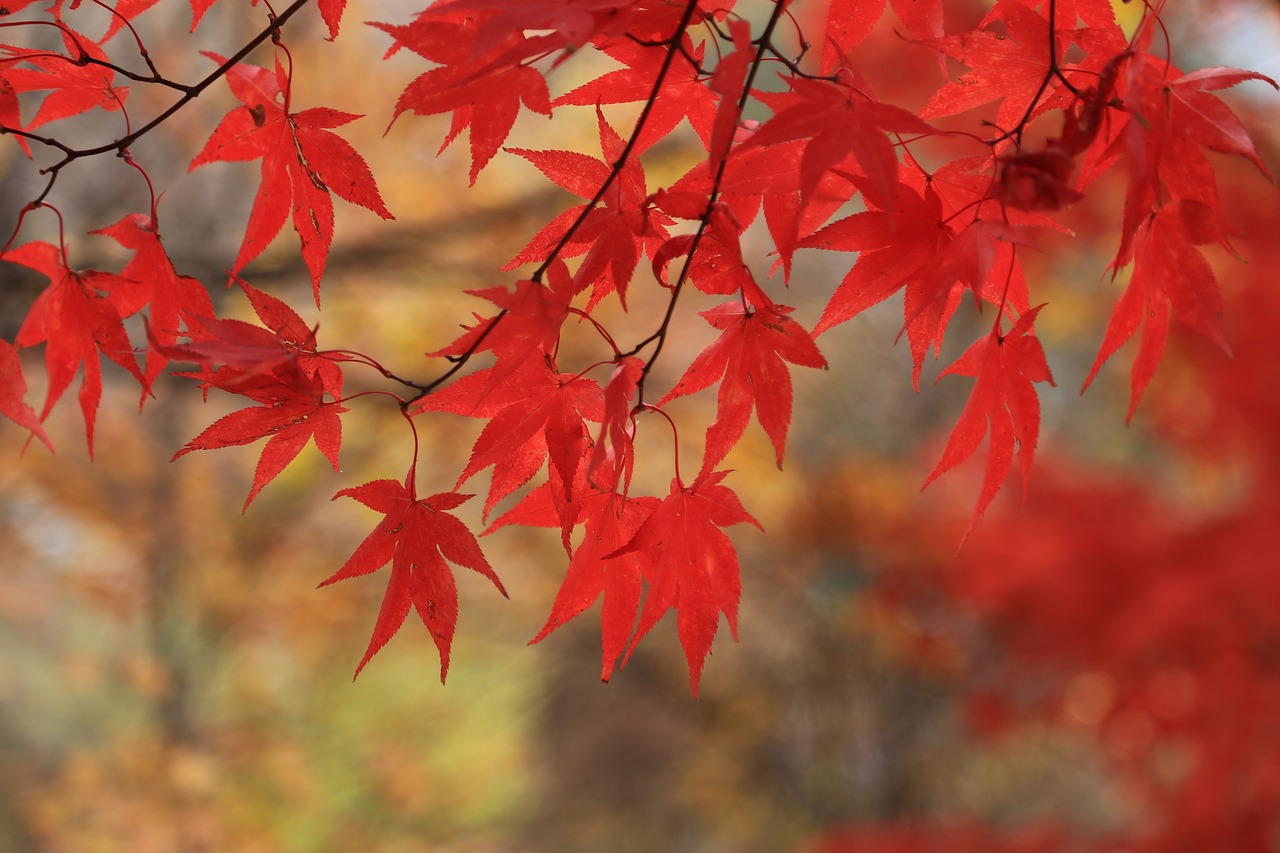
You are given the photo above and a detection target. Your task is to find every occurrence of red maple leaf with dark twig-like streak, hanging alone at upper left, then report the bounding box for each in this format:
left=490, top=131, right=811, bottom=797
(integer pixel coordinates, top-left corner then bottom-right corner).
left=189, top=53, right=393, bottom=298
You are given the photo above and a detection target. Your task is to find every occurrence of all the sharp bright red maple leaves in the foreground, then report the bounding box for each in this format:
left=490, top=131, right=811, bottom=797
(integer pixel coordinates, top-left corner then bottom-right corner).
left=0, top=0, right=1266, bottom=693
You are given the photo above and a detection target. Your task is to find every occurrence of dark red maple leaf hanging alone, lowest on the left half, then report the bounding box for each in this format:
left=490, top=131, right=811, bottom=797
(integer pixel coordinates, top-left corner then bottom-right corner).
left=320, top=473, right=507, bottom=683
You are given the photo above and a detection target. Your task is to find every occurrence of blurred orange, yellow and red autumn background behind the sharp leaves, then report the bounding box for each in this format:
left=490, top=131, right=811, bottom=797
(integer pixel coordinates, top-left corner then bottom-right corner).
left=0, top=0, right=1280, bottom=853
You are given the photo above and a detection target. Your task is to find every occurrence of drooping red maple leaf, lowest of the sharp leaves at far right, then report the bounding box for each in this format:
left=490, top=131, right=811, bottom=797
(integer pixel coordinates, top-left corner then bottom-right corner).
left=1080, top=200, right=1231, bottom=421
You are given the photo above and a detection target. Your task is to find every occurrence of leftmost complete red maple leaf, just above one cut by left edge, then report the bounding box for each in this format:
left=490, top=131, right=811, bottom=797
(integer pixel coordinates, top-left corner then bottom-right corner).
left=0, top=242, right=147, bottom=457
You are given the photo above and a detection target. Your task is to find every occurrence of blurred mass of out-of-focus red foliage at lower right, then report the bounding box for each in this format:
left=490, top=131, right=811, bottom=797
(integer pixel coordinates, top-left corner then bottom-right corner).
left=806, top=186, right=1280, bottom=853
